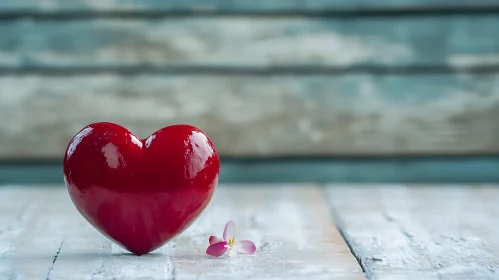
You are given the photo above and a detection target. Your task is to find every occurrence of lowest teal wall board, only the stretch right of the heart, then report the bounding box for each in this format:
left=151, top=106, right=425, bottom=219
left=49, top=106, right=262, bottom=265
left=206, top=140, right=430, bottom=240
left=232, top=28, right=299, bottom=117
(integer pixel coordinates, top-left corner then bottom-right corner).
left=220, top=157, right=499, bottom=183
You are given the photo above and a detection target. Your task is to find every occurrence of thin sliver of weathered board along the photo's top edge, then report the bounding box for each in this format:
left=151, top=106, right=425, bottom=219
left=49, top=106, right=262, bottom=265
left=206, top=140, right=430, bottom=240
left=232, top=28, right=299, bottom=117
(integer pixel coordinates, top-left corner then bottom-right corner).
left=0, top=0, right=498, bottom=12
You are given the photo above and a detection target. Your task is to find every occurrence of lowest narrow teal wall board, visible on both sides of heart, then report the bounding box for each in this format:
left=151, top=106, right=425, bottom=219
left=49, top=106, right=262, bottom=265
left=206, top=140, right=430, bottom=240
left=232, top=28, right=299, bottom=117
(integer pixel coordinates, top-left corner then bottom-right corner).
left=0, top=157, right=499, bottom=185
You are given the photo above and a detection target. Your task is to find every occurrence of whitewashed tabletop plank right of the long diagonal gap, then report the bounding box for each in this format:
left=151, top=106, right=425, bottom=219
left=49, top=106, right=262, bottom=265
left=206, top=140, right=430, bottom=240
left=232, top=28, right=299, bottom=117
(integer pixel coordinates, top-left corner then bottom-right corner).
left=327, top=185, right=499, bottom=279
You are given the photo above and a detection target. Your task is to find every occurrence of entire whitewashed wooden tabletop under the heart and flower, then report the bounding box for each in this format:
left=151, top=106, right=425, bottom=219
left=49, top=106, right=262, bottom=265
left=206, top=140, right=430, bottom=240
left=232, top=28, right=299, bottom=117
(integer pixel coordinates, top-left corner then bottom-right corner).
left=0, top=185, right=499, bottom=280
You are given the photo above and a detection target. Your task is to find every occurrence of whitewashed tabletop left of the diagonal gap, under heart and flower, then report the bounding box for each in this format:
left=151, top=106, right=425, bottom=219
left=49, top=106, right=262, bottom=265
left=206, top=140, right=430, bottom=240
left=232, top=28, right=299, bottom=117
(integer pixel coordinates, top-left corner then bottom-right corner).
left=0, top=186, right=364, bottom=280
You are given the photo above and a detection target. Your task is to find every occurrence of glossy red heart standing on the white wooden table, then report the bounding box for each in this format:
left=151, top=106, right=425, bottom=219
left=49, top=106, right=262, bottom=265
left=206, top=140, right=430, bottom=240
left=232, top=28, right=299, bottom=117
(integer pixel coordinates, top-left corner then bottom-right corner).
left=64, top=123, right=220, bottom=255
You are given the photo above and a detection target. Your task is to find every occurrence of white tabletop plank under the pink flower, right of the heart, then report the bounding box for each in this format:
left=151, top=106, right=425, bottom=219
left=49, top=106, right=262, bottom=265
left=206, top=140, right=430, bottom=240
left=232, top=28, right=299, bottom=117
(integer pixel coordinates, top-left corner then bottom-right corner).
left=168, top=185, right=364, bottom=279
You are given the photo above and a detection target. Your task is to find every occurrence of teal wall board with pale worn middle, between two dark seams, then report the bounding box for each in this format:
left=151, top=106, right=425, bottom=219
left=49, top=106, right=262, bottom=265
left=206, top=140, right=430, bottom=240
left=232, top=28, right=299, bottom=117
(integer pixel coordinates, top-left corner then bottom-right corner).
left=0, top=16, right=499, bottom=70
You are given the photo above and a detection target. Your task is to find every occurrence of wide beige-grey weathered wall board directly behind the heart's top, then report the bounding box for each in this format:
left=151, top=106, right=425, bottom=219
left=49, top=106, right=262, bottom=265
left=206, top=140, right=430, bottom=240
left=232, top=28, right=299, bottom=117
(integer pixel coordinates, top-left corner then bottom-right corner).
left=0, top=74, right=499, bottom=159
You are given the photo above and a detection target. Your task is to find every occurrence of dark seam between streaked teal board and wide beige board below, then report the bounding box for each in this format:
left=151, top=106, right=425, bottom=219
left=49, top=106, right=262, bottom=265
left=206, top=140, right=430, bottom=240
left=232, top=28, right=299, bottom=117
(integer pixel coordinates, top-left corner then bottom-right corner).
left=0, top=64, right=499, bottom=76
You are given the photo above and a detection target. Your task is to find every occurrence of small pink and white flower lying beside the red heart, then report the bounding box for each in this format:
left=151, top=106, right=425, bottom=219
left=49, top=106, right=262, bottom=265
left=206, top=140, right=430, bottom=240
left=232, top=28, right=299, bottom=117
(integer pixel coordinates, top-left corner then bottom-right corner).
left=206, top=221, right=256, bottom=257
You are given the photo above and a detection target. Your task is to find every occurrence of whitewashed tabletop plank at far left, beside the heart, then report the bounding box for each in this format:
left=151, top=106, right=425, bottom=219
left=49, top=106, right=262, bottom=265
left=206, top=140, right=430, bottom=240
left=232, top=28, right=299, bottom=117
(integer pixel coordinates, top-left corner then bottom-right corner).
left=0, top=186, right=83, bottom=279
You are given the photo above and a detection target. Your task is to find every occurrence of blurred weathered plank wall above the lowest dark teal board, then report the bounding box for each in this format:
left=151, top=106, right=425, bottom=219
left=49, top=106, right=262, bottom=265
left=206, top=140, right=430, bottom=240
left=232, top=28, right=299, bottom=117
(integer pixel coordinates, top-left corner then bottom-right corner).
left=0, top=0, right=499, bottom=160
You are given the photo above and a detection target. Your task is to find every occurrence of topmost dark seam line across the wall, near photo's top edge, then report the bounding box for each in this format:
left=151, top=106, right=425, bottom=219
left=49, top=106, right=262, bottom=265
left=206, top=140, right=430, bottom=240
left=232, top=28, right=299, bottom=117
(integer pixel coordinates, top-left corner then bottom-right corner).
left=0, top=4, right=499, bottom=21
